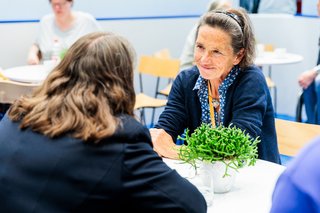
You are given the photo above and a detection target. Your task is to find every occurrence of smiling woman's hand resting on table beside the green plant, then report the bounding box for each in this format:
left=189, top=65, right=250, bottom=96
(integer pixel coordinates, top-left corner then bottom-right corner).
left=149, top=128, right=180, bottom=159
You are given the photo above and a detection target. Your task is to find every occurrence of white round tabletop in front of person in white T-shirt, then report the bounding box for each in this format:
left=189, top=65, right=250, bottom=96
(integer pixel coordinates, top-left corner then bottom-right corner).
left=2, top=65, right=53, bottom=83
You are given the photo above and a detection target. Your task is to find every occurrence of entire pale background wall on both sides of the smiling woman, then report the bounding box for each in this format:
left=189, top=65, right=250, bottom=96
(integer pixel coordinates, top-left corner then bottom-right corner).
left=0, top=10, right=320, bottom=123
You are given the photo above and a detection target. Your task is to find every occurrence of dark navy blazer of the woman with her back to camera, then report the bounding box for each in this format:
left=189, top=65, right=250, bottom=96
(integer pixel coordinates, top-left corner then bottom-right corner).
left=0, top=116, right=207, bottom=213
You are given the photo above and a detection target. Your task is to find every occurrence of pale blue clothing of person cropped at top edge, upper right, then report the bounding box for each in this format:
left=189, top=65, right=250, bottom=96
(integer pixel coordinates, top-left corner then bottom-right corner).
left=258, top=0, right=297, bottom=15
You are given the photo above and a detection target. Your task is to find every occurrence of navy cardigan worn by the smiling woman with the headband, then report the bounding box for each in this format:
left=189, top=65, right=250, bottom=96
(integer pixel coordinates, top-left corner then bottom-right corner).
left=155, top=66, right=280, bottom=163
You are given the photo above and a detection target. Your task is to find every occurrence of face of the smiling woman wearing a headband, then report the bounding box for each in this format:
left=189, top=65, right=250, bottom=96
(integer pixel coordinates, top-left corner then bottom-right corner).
left=194, top=25, right=242, bottom=80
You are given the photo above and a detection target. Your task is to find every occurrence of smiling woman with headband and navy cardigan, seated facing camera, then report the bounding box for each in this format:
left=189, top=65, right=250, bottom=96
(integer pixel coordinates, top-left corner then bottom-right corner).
left=150, top=8, right=280, bottom=163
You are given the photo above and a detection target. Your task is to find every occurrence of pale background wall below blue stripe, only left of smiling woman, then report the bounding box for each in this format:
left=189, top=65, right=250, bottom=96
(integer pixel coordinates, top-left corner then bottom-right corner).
left=0, top=18, right=197, bottom=125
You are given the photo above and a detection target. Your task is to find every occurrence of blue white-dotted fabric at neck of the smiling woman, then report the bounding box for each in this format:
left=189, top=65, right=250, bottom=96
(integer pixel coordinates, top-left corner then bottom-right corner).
left=193, top=66, right=241, bottom=126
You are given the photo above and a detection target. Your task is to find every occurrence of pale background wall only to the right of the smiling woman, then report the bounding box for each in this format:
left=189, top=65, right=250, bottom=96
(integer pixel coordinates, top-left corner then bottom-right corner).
left=251, top=14, right=320, bottom=119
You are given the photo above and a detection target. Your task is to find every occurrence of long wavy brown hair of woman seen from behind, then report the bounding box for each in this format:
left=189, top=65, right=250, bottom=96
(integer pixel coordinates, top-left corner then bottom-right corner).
left=8, top=32, right=135, bottom=142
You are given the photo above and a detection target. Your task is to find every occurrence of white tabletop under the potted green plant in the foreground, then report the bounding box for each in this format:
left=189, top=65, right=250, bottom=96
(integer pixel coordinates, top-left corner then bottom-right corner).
left=164, top=159, right=285, bottom=213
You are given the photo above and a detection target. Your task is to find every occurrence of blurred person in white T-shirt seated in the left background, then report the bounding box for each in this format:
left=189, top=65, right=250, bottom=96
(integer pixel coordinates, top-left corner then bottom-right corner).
left=27, top=0, right=101, bottom=64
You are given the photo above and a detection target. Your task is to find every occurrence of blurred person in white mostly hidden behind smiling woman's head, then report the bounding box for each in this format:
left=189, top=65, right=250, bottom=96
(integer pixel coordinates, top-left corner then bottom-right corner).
left=180, top=0, right=232, bottom=70
